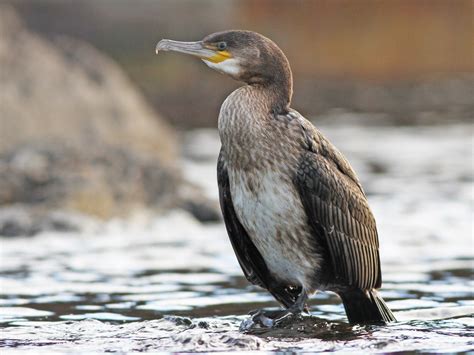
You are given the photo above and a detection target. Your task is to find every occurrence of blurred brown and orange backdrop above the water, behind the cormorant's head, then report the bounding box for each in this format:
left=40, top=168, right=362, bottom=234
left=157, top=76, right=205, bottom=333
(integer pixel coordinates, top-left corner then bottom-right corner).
left=3, top=0, right=474, bottom=128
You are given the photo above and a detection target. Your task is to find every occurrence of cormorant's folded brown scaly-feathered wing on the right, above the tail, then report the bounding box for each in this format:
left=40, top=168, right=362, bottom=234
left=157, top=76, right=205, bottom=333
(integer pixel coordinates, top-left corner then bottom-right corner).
left=294, top=120, right=382, bottom=289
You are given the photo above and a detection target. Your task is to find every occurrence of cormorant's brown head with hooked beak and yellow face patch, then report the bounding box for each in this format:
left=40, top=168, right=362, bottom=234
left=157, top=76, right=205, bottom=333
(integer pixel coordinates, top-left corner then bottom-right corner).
left=156, top=30, right=292, bottom=89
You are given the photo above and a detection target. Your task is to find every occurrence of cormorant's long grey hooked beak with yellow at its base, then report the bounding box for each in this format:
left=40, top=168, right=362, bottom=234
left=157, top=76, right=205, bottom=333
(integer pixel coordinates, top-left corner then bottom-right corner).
left=155, top=39, right=231, bottom=63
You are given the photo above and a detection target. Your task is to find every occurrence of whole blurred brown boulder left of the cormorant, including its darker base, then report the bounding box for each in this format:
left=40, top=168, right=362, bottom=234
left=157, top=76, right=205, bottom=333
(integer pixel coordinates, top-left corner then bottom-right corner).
left=0, top=6, right=180, bottom=218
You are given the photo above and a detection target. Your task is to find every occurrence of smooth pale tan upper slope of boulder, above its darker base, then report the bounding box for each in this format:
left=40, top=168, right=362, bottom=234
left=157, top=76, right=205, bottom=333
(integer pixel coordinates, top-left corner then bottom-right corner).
left=0, top=6, right=176, bottom=161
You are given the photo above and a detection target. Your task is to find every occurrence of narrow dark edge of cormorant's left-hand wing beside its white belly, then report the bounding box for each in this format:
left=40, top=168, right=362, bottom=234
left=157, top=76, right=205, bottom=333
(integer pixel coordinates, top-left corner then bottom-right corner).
left=217, top=149, right=301, bottom=307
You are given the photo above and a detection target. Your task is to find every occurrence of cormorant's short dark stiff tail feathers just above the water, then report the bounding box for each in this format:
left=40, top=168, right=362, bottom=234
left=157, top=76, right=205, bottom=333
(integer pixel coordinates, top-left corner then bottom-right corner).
left=339, top=289, right=396, bottom=324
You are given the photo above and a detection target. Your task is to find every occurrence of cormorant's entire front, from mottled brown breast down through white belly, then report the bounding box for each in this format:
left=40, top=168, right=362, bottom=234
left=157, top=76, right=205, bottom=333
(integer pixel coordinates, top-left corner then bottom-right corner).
left=219, top=86, right=319, bottom=291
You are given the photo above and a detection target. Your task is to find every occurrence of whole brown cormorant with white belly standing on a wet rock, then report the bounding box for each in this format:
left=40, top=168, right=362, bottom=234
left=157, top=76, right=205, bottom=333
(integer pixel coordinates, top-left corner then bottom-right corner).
left=156, top=30, right=395, bottom=323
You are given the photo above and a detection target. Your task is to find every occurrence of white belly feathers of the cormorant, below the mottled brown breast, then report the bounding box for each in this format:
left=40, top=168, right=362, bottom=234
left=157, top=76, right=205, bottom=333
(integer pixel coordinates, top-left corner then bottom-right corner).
left=229, top=168, right=318, bottom=291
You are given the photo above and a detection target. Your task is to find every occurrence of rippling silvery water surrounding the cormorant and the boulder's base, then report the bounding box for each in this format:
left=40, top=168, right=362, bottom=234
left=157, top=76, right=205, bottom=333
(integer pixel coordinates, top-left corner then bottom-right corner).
left=0, top=125, right=474, bottom=354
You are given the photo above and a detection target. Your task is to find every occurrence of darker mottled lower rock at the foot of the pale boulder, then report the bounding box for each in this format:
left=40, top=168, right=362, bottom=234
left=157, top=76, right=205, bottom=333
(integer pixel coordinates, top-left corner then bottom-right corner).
left=0, top=142, right=183, bottom=219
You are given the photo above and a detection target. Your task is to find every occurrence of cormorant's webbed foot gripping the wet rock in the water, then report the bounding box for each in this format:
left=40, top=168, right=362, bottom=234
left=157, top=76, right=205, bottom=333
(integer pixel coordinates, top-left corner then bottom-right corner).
left=240, top=308, right=301, bottom=331
